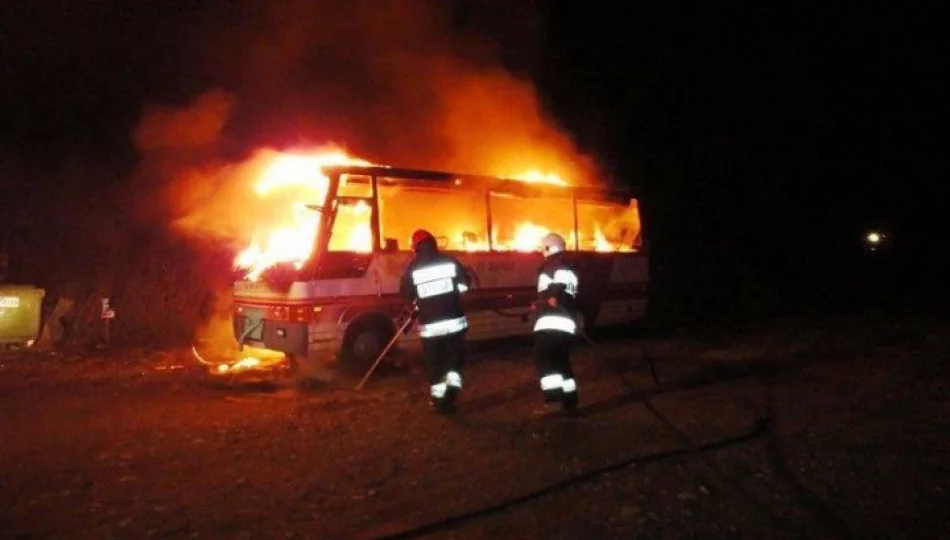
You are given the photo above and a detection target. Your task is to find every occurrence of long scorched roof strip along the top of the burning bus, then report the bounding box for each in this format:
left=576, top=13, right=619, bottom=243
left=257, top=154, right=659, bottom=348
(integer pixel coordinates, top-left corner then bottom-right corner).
left=323, top=165, right=634, bottom=204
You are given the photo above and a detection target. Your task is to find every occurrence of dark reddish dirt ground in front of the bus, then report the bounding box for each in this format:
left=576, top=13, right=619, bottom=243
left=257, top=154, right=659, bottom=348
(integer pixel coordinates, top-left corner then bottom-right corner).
left=0, top=314, right=950, bottom=539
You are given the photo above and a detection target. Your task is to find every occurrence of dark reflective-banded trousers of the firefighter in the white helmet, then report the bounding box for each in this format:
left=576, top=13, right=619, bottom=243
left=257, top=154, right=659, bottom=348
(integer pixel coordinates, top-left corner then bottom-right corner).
left=533, top=330, right=577, bottom=405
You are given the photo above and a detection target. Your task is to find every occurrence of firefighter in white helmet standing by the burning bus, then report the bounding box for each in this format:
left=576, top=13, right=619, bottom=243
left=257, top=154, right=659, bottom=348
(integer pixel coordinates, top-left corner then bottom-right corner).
left=533, top=233, right=577, bottom=412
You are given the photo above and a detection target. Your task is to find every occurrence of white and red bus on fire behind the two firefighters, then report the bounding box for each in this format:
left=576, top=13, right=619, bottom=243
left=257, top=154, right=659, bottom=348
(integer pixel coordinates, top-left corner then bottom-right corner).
left=232, top=163, right=648, bottom=378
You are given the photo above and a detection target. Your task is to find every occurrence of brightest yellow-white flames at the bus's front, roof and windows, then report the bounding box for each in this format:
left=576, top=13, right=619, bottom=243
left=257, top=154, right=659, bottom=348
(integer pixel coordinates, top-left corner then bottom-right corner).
left=234, top=150, right=628, bottom=281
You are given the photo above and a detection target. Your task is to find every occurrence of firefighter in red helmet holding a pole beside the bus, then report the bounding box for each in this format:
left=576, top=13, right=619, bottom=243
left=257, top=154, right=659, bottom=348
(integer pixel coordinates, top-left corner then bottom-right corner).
left=400, top=229, right=469, bottom=413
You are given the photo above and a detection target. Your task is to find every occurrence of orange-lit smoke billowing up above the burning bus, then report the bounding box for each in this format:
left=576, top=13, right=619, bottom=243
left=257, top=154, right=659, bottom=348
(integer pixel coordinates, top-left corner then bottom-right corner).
left=128, top=0, right=599, bottom=346
